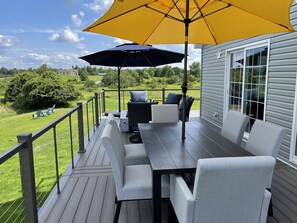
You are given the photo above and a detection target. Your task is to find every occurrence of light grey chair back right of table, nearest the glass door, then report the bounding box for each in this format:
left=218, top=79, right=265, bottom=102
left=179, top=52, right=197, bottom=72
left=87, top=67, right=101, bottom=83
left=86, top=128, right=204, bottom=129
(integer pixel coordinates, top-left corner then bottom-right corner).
left=221, top=110, right=250, bottom=145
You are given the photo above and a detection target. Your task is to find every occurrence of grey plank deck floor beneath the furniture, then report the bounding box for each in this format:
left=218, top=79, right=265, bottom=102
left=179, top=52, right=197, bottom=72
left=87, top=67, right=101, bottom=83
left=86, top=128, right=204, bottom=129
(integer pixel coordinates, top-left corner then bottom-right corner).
left=39, top=115, right=297, bottom=223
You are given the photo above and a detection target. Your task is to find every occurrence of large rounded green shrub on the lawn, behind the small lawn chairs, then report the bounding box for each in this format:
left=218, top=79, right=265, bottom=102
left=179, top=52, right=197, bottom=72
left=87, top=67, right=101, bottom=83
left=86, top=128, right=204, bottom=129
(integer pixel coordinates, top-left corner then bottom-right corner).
left=5, top=71, right=79, bottom=109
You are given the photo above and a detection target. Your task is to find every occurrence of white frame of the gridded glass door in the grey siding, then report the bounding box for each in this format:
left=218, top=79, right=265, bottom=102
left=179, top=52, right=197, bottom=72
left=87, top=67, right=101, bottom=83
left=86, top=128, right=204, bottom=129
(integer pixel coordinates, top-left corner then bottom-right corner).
left=223, top=39, right=270, bottom=134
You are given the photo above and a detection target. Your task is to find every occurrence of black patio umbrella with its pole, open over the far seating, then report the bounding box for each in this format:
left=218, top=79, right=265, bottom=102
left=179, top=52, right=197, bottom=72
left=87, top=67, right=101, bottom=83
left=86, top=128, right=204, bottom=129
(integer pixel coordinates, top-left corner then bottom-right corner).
left=80, top=43, right=184, bottom=115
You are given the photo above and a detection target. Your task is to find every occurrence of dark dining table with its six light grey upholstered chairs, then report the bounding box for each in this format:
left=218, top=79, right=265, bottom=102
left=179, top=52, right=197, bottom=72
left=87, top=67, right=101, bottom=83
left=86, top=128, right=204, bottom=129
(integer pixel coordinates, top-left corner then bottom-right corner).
left=102, top=91, right=286, bottom=223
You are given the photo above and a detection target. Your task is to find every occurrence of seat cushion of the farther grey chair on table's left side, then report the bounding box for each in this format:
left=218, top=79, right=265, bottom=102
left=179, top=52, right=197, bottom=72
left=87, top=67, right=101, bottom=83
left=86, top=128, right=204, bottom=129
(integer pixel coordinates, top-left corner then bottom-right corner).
left=124, top=143, right=149, bottom=165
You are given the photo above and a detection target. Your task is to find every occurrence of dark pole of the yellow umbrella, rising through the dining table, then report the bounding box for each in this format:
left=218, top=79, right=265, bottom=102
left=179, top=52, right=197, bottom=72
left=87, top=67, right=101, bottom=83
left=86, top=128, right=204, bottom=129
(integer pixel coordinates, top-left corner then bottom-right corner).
left=182, top=0, right=190, bottom=140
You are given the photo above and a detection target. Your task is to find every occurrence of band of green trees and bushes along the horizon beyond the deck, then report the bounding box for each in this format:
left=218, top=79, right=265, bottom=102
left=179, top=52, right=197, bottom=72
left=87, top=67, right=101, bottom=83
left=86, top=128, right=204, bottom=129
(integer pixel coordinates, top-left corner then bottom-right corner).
left=0, top=62, right=200, bottom=110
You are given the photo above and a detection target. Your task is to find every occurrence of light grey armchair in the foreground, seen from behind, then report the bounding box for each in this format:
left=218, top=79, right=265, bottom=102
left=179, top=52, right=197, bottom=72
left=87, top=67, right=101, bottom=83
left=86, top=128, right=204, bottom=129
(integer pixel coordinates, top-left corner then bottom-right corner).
left=170, top=156, right=275, bottom=223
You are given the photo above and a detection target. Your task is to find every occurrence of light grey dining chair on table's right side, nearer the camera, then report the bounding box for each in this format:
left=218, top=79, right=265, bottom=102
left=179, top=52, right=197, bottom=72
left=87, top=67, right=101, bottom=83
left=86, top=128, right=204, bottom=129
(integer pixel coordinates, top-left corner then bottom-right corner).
left=245, top=120, right=287, bottom=216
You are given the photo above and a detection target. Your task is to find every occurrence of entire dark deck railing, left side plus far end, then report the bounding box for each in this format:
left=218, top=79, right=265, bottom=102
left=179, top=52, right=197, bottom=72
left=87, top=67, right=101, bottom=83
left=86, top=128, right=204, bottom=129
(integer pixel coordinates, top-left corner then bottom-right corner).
left=0, top=88, right=199, bottom=223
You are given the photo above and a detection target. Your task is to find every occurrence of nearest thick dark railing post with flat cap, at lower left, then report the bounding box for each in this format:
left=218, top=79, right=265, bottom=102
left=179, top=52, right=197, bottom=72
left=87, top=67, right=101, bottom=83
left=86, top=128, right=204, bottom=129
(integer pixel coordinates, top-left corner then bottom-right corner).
left=17, top=133, right=38, bottom=223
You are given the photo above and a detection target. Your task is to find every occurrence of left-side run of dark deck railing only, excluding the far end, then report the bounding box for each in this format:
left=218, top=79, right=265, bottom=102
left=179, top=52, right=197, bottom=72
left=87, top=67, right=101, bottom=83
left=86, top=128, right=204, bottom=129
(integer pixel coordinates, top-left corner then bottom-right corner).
left=0, top=92, right=104, bottom=223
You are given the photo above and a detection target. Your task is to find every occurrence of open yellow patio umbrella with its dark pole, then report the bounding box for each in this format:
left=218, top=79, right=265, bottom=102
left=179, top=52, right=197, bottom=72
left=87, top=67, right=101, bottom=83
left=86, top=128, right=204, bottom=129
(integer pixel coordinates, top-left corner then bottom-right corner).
left=84, top=0, right=294, bottom=139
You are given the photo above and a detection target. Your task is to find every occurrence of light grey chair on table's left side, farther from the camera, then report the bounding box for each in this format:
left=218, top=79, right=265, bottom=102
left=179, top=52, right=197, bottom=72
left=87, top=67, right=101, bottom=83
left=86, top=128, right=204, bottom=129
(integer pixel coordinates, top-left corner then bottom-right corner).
left=107, top=113, right=149, bottom=165
